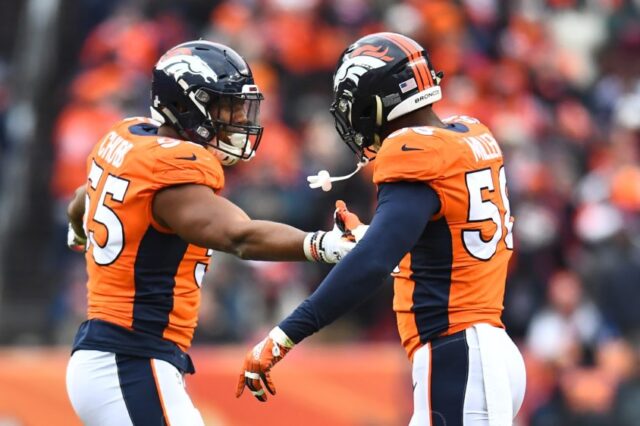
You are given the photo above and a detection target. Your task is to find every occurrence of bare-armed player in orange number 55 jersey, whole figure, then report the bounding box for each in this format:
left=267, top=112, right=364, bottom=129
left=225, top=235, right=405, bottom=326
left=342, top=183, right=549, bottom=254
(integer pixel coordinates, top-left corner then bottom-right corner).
left=67, top=40, right=364, bottom=426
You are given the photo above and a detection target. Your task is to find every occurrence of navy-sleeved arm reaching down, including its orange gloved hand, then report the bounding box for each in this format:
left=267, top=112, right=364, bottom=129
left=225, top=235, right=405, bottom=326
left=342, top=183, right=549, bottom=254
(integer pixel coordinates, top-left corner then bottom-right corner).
left=236, top=182, right=440, bottom=401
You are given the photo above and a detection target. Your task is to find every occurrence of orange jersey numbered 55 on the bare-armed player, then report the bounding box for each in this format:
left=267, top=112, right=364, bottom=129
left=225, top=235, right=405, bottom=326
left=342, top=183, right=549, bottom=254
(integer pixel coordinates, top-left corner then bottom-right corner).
left=84, top=118, right=224, bottom=351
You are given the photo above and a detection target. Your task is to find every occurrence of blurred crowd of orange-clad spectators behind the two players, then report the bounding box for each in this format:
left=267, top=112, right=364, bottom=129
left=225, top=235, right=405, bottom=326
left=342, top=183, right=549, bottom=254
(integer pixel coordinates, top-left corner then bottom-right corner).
left=0, top=0, right=640, bottom=426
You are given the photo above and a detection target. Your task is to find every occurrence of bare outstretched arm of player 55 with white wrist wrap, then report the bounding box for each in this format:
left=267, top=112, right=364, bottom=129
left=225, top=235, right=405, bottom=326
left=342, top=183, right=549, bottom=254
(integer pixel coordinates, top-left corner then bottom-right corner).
left=153, top=184, right=353, bottom=263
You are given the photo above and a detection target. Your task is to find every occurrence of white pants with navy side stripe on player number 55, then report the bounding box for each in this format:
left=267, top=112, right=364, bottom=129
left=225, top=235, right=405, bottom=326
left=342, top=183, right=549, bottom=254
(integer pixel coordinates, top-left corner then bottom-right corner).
left=67, top=350, right=204, bottom=426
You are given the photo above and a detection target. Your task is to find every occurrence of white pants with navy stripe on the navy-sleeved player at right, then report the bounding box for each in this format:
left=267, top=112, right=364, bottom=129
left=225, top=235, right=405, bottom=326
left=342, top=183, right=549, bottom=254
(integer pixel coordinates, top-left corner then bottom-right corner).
left=409, top=324, right=526, bottom=426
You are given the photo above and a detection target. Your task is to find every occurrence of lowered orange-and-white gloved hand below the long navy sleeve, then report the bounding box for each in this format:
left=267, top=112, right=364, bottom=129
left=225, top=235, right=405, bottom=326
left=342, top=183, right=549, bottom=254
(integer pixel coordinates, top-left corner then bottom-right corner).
left=236, top=327, right=294, bottom=402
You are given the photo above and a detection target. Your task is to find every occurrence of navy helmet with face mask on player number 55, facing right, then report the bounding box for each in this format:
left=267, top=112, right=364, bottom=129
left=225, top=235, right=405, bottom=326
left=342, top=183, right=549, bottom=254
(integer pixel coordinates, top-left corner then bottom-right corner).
left=151, top=40, right=264, bottom=165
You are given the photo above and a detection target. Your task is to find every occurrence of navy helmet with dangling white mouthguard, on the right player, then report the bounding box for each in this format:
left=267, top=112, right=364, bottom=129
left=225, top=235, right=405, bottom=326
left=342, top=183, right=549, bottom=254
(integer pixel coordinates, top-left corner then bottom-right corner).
left=330, top=33, right=443, bottom=157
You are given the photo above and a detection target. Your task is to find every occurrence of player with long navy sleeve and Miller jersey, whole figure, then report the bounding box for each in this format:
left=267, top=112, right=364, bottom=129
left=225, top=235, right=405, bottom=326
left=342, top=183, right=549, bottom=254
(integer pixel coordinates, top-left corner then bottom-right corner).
left=236, top=33, right=525, bottom=426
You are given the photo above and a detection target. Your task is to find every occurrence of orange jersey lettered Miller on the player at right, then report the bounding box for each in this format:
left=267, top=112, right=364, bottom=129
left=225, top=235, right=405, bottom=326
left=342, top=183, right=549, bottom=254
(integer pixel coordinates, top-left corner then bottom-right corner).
left=373, top=116, right=513, bottom=357
